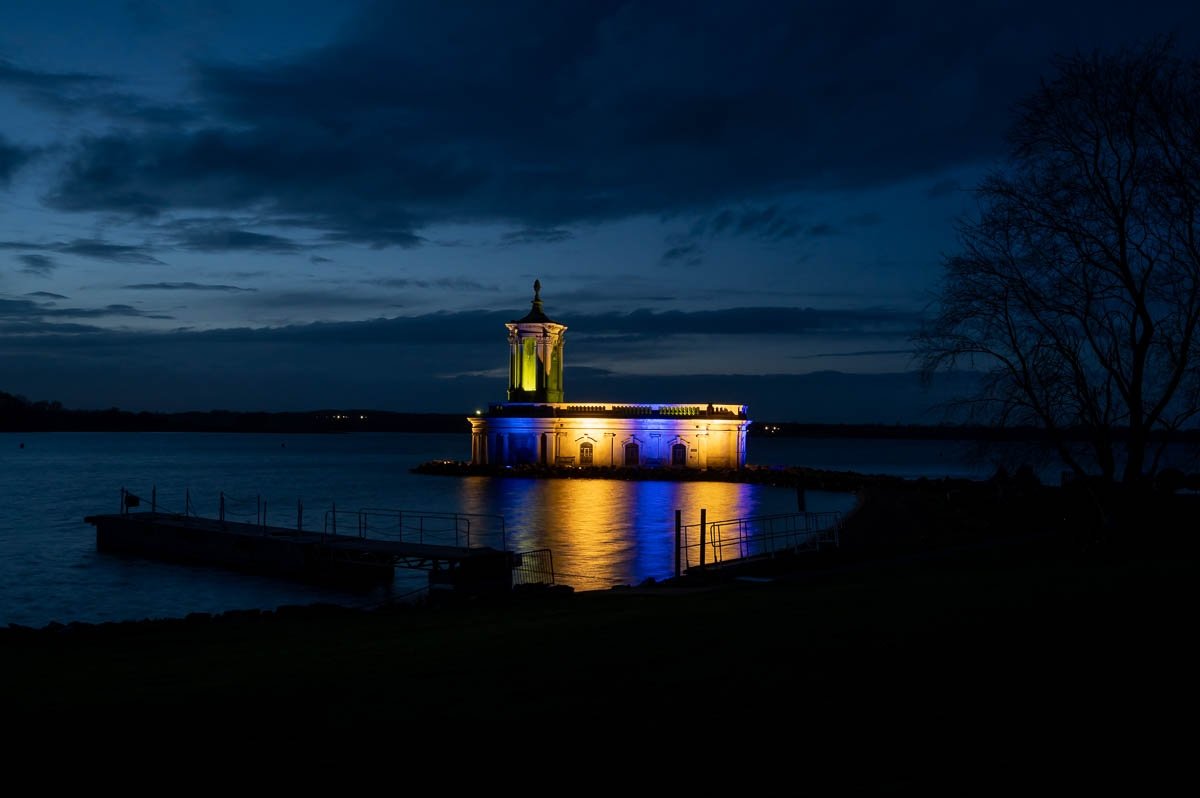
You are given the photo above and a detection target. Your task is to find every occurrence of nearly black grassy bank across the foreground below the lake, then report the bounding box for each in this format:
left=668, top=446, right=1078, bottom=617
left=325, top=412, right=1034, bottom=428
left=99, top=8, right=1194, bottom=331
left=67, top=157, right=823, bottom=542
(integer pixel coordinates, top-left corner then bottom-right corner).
left=0, top=475, right=1196, bottom=791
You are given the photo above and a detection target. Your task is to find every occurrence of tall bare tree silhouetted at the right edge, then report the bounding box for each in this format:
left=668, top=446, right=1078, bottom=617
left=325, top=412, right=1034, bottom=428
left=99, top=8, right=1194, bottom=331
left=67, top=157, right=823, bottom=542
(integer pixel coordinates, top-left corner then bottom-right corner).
left=917, top=40, right=1200, bottom=482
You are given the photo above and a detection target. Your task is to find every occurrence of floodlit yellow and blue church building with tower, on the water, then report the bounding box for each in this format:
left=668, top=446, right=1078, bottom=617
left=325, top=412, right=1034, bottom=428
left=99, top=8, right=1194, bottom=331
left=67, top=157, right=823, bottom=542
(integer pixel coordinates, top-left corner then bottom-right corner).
left=470, top=281, right=750, bottom=469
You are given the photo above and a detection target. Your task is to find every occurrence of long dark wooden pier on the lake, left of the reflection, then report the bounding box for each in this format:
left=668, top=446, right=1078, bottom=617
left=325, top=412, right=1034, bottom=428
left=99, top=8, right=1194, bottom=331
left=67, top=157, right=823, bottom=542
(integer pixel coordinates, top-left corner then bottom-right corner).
left=84, top=492, right=523, bottom=593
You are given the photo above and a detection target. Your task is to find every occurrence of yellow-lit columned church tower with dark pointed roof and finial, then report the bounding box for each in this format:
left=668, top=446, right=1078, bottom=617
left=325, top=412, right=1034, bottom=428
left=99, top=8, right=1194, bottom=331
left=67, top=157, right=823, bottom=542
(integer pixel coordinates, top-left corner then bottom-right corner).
left=504, top=280, right=566, bottom=402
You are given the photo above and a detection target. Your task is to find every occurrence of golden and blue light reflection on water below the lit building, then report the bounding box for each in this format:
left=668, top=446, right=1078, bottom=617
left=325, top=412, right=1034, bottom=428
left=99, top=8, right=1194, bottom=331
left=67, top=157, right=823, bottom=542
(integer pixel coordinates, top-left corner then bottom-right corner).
left=458, top=476, right=762, bottom=590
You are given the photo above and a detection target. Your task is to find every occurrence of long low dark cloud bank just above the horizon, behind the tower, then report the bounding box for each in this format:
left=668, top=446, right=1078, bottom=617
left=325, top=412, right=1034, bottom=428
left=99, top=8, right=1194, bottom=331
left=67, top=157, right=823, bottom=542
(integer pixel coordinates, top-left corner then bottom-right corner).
left=0, top=305, right=964, bottom=420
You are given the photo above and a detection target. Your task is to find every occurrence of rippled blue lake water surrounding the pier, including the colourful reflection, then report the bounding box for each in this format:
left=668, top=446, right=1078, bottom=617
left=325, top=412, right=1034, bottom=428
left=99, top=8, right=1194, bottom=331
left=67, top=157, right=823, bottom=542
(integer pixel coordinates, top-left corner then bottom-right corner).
left=0, top=433, right=1132, bottom=626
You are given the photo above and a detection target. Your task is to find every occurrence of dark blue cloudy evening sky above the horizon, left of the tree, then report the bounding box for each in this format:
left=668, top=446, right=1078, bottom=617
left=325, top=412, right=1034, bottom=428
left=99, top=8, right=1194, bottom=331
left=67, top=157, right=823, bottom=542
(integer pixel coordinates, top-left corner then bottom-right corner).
left=0, top=0, right=1200, bottom=422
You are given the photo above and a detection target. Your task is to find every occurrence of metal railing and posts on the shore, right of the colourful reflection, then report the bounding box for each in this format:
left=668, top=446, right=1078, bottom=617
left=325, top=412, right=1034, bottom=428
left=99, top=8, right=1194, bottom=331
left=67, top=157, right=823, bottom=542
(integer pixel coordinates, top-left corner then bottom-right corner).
left=674, top=510, right=841, bottom=576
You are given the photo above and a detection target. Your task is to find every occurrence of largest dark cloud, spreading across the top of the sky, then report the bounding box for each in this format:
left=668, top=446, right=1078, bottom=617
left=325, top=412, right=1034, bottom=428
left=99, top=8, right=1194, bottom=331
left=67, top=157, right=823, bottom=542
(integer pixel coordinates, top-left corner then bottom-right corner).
left=42, top=0, right=1200, bottom=246
